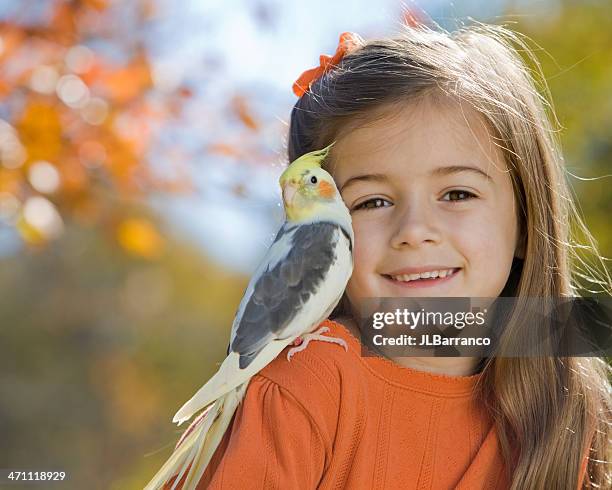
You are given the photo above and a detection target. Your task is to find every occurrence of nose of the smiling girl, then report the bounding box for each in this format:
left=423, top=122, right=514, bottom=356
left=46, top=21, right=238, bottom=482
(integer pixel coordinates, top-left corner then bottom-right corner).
left=391, top=205, right=441, bottom=249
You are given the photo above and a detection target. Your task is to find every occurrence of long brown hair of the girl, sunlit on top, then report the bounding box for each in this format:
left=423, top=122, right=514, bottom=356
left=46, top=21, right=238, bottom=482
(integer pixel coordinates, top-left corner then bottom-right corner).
left=288, top=24, right=612, bottom=489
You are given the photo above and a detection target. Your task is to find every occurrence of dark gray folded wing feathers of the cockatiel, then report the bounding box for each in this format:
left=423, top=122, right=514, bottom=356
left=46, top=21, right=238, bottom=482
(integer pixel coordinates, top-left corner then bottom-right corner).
left=230, top=222, right=341, bottom=368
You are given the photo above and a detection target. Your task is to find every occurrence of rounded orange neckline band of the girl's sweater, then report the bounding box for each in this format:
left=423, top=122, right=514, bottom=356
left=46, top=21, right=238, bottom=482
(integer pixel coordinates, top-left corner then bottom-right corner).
left=323, top=319, right=482, bottom=395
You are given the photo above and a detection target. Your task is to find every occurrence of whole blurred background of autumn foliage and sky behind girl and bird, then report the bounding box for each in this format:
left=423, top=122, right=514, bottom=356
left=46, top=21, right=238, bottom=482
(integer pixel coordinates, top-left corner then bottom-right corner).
left=0, top=0, right=612, bottom=489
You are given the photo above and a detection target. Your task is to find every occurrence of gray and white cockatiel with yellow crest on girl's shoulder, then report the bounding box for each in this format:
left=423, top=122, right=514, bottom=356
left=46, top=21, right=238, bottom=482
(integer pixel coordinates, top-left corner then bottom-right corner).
left=146, top=143, right=354, bottom=489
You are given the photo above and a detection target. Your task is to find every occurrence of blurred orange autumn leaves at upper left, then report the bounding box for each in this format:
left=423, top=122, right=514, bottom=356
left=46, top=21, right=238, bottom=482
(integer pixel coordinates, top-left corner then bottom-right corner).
left=0, top=0, right=201, bottom=255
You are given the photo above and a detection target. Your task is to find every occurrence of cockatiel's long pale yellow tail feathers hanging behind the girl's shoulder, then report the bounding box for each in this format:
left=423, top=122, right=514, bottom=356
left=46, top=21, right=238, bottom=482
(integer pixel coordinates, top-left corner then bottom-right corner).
left=145, top=381, right=249, bottom=490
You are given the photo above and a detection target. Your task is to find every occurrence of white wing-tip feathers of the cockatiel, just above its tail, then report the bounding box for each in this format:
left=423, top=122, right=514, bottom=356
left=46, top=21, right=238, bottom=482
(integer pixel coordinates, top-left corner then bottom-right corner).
left=172, top=339, right=293, bottom=425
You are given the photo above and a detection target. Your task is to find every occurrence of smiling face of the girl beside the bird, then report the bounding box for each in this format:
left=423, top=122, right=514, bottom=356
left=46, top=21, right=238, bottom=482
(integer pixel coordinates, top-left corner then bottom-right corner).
left=332, top=98, right=519, bottom=307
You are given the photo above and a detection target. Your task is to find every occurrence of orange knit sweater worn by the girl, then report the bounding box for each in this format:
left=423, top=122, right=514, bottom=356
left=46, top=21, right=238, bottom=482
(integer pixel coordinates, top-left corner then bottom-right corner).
left=166, top=320, right=586, bottom=490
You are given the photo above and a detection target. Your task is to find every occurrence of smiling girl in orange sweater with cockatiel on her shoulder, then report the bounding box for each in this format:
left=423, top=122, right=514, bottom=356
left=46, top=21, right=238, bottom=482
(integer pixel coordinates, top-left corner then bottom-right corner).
left=165, top=22, right=612, bottom=490
